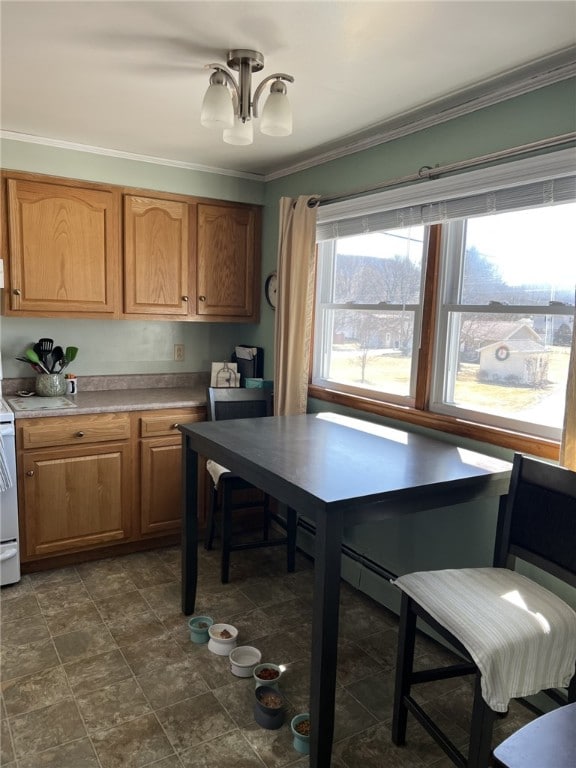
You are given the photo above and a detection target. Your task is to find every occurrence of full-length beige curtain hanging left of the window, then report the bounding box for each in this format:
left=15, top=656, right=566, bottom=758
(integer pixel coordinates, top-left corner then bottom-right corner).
left=274, top=195, right=317, bottom=416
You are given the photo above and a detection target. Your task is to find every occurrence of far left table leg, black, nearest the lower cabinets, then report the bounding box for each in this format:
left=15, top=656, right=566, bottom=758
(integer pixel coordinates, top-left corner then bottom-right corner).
left=182, top=435, right=198, bottom=615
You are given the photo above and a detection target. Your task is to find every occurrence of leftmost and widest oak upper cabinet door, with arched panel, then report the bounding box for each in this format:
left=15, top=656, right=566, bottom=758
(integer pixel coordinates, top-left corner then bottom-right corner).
left=7, top=179, right=120, bottom=317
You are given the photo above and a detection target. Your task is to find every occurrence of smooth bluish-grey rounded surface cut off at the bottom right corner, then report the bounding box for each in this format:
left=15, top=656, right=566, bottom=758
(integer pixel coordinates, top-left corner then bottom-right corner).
left=494, top=704, right=576, bottom=768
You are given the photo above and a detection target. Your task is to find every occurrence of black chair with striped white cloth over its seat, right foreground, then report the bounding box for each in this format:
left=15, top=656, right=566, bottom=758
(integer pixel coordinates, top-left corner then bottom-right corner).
left=392, top=454, right=576, bottom=768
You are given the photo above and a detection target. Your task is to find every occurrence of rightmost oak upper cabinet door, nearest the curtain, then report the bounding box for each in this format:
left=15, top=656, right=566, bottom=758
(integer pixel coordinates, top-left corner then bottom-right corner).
left=196, top=204, right=260, bottom=321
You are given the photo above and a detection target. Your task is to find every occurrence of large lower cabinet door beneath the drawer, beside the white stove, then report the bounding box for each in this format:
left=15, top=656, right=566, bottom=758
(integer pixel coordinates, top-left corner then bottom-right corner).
left=21, top=443, right=132, bottom=559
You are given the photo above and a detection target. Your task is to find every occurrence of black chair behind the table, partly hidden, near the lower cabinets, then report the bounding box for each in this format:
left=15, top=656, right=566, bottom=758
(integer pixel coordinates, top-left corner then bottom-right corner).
left=204, top=387, right=297, bottom=584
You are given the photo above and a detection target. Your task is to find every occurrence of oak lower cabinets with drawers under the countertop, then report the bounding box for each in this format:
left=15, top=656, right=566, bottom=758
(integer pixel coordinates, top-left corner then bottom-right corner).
left=16, top=407, right=206, bottom=565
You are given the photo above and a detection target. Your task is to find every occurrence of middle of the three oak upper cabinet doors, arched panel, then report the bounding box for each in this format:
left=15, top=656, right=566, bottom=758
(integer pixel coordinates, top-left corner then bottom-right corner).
left=124, top=200, right=190, bottom=317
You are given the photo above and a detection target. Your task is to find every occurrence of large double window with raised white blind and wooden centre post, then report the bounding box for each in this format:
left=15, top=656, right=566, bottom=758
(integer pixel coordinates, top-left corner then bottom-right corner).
left=311, top=152, right=576, bottom=449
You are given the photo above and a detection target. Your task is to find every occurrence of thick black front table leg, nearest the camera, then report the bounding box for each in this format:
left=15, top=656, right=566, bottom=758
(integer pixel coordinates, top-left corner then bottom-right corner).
left=310, top=512, right=343, bottom=768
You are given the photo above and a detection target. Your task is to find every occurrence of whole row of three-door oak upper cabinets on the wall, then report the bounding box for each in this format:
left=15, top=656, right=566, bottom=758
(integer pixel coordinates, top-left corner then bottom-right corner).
left=0, top=171, right=262, bottom=323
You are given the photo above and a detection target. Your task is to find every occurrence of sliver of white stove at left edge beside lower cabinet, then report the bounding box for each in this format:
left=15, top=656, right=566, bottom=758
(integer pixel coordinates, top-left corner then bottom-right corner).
left=0, top=398, right=20, bottom=586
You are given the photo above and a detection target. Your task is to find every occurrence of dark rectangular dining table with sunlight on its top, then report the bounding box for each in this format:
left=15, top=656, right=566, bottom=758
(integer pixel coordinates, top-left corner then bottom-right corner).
left=180, top=413, right=511, bottom=768
